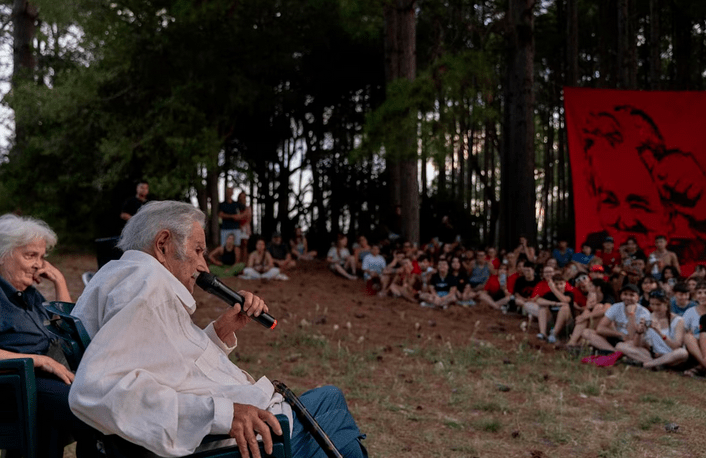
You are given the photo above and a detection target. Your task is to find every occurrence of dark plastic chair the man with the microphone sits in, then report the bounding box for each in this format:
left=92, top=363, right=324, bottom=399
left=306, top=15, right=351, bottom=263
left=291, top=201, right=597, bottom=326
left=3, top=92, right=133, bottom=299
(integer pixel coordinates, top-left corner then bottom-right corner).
left=39, top=301, right=292, bottom=458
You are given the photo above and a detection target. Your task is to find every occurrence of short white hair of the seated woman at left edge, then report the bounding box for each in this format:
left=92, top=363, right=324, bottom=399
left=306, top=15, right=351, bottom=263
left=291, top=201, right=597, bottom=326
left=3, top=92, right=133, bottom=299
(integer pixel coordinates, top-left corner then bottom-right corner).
left=0, top=213, right=57, bottom=260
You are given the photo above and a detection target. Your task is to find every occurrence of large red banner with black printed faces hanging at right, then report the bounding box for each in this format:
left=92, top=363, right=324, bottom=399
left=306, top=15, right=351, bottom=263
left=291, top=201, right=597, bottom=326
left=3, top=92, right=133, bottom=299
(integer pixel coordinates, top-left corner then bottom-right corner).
left=564, top=87, right=706, bottom=275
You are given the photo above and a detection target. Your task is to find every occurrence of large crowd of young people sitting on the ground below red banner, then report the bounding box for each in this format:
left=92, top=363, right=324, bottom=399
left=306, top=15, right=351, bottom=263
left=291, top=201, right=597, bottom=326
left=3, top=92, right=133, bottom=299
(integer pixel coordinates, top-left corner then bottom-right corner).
left=327, top=236, right=706, bottom=376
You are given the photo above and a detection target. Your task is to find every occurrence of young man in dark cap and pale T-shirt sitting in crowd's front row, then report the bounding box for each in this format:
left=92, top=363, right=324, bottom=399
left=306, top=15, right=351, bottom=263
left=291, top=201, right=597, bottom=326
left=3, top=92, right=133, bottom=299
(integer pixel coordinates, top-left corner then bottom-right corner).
left=583, top=283, right=651, bottom=352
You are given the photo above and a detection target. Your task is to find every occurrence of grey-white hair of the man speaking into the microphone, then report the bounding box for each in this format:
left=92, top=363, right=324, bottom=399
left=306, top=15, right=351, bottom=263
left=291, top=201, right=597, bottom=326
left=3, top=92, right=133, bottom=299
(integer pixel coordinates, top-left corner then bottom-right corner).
left=118, top=200, right=206, bottom=259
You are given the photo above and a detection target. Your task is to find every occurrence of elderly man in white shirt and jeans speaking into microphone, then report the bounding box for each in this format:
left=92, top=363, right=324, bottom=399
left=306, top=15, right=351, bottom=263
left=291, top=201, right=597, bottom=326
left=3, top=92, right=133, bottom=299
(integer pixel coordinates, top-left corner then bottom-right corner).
left=69, top=201, right=367, bottom=457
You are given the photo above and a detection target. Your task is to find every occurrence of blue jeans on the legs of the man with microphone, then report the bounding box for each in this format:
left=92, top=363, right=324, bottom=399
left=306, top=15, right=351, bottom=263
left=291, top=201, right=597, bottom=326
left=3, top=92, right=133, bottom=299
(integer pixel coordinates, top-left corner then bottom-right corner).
left=292, top=385, right=368, bottom=458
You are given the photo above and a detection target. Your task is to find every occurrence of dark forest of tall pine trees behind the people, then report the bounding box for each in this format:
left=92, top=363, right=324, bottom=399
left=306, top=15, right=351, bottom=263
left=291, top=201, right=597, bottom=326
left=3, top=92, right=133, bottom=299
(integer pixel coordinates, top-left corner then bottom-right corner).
left=0, top=0, right=706, bottom=254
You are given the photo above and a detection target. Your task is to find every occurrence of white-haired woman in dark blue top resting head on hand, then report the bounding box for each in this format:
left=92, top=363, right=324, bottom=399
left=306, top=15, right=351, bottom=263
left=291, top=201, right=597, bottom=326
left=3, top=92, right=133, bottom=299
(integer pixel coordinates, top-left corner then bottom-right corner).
left=0, top=214, right=100, bottom=457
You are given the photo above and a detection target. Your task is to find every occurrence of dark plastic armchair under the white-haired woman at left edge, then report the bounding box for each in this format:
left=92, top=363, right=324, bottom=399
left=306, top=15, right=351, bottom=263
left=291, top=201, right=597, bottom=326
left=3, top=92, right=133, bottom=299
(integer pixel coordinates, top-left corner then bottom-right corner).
left=0, top=358, right=37, bottom=458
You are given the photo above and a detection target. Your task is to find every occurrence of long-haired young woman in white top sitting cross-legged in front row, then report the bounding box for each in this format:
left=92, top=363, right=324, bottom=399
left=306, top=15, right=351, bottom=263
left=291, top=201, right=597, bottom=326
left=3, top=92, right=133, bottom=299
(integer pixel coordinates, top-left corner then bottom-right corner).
left=620, top=289, right=689, bottom=368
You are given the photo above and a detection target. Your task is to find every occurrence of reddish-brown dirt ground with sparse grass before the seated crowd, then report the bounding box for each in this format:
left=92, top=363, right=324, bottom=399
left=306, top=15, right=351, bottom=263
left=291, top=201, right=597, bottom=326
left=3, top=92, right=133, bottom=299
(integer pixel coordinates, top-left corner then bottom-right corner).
left=49, top=254, right=706, bottom=458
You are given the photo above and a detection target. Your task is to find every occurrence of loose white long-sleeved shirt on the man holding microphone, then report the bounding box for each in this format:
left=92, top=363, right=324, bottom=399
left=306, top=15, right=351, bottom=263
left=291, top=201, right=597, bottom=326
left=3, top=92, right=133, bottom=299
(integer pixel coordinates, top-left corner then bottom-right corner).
left=69, top=251, right=292, bottom=456
